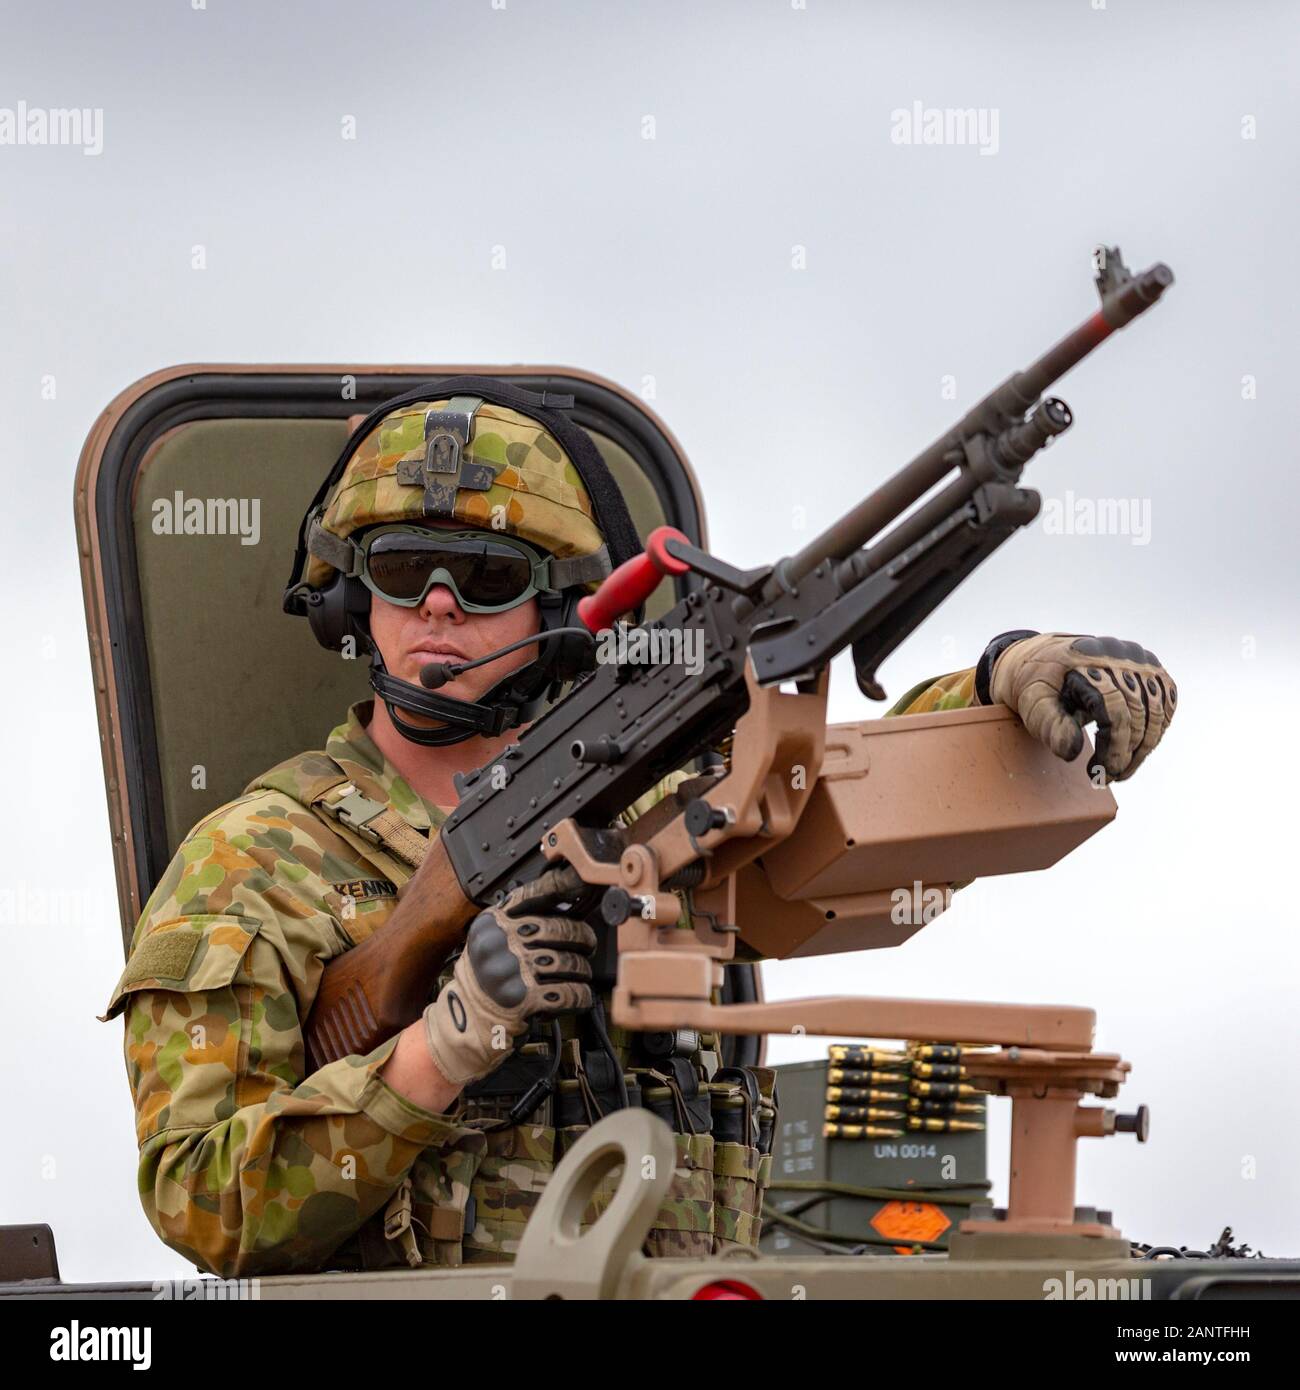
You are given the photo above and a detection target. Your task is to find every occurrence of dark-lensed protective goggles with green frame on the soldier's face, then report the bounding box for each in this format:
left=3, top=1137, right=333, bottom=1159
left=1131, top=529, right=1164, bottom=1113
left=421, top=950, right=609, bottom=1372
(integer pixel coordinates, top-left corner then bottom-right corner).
left=357, top=525, right=551, bottom=613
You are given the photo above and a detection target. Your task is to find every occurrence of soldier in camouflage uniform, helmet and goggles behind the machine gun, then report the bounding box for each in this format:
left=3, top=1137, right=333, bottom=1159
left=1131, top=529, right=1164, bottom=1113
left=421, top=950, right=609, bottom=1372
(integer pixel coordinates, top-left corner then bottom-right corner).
left=107, top=378, right=1175, bottom=1276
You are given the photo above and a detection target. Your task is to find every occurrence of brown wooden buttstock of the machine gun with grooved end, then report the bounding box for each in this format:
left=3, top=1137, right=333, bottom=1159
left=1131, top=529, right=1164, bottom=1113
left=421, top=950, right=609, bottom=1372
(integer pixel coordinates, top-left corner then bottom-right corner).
left=304, top=835, right=478, bottom=1074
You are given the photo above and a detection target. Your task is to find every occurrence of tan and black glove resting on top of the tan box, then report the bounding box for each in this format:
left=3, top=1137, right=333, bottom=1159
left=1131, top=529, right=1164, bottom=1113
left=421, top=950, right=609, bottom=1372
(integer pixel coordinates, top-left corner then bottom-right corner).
left=975, top=631, right=1178, bottom=781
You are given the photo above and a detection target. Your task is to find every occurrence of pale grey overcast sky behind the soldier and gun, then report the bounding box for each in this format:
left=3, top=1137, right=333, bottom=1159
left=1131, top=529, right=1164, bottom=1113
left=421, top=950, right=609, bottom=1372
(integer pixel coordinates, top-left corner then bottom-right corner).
left=0, top=0, right=1300, bottom=1280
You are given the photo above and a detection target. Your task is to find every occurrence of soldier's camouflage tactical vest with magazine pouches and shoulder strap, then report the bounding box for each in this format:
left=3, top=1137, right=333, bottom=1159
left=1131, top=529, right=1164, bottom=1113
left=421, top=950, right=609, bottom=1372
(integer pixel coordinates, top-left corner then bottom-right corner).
left=247, top=752, right=776, bottom=1269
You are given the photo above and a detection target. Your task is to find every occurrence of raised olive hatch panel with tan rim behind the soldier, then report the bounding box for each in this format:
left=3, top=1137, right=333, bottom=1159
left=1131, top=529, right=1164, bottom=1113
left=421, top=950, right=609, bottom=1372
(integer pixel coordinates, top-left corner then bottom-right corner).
left=75, top=364, right=759, bottom=1062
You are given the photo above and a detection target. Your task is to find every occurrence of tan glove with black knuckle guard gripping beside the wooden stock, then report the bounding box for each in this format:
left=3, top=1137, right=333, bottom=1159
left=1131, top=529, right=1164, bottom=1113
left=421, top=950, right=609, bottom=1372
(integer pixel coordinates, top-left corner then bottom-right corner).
left=424, top=869, right=596, bottom=1086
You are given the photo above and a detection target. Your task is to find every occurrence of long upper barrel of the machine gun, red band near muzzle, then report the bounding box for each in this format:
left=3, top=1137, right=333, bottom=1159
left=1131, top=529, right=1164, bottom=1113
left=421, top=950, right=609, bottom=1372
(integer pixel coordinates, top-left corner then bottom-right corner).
left=786, top=263, right=1173, bottom=580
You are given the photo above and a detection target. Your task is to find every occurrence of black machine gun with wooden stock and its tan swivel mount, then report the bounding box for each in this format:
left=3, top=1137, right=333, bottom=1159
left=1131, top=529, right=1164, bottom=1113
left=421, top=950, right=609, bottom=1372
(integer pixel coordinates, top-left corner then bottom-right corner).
left=307, top=249, right=1173, bottom=1068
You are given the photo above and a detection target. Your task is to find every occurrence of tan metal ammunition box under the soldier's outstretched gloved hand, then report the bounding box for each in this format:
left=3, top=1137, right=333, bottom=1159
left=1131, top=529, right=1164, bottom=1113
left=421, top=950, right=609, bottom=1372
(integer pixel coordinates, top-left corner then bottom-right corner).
left=736, top=705, right=1115, bottom=959
